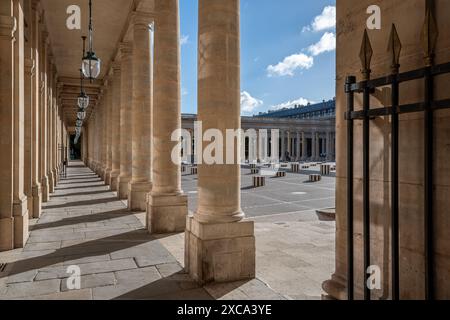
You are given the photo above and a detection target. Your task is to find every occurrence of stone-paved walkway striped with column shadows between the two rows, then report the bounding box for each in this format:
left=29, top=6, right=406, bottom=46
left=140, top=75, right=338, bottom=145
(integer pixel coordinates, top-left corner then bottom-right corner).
left=0, top=162, right=281, bottom=300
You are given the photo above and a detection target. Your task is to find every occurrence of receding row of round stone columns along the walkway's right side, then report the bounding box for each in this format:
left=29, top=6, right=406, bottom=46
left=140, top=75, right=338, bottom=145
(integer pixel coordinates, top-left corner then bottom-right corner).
left=82, top=0, right=255, bottom=283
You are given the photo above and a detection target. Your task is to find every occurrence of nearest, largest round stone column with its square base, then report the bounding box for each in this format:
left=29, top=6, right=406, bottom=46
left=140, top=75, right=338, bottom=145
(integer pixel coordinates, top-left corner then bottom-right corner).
left=185, top=0, right=255, bottom=284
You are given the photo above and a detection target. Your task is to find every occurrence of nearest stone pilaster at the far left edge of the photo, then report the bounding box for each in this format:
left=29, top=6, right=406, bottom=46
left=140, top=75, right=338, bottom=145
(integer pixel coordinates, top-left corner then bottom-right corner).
left=0, top=2, right=16, bottom=251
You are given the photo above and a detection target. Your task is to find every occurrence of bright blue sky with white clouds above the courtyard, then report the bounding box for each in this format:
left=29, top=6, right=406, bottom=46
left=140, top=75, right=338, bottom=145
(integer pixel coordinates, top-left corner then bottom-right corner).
left=180, top=0, right=336, bottom=115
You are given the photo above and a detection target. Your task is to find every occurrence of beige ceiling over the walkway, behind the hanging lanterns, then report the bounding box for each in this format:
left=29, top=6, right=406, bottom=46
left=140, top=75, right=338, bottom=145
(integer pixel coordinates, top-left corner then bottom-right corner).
left=41, top=0, right=135, bottom=126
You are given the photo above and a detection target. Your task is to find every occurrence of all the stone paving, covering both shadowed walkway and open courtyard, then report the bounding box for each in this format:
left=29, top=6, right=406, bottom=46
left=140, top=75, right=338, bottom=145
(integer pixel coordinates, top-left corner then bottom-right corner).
left=0, top=162, right=335, bottom=300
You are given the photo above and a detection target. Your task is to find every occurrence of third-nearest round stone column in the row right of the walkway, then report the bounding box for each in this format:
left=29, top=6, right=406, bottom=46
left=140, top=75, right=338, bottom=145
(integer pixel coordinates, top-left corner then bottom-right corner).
left=128, top=13, right=153, bottom=211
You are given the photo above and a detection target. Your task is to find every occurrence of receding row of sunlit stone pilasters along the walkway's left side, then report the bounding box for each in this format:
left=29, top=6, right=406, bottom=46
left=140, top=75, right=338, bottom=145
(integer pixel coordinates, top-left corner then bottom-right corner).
left=0, top=0, right=68, bottom=251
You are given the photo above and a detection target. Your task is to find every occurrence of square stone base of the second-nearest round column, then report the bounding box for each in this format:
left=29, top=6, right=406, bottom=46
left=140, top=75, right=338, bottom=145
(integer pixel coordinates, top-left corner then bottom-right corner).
left=147, top=193, right=188, bottom=234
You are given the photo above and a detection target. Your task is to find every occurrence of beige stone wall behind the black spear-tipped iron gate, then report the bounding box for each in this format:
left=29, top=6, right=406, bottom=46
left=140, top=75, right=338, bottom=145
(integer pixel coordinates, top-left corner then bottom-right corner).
left=324, top=0, right=450, bottom=299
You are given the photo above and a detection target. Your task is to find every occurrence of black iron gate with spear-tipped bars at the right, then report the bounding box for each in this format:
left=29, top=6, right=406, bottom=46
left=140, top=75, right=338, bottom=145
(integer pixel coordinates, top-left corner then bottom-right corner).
left=345, top=0, right=450, bottom=300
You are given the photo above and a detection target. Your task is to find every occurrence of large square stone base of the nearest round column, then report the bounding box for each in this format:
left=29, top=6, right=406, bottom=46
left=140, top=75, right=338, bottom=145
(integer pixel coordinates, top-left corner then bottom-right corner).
left=185, top=217, right=256, bottom=285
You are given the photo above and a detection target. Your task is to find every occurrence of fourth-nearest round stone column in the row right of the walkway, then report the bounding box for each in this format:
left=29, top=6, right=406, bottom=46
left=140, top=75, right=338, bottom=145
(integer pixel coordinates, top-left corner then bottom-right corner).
left=117, top=43, right=133, bottom=199
